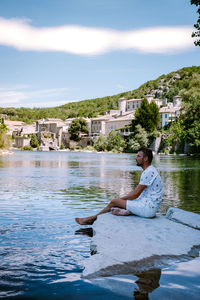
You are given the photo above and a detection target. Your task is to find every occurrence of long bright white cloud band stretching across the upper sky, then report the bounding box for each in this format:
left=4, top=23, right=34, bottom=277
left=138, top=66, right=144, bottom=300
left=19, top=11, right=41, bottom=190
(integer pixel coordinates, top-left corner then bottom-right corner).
left=0, top=18, right=194, bottom=55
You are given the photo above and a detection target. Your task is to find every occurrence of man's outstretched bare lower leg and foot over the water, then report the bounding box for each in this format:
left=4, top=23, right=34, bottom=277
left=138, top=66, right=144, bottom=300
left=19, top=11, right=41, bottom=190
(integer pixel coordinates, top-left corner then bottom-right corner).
left=75, top=198, right=126, bottom=225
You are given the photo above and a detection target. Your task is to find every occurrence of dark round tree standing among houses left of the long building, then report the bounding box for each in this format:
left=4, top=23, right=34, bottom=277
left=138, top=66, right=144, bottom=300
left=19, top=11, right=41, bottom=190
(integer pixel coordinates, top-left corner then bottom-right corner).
left=69, top=118, right=89, bottom=141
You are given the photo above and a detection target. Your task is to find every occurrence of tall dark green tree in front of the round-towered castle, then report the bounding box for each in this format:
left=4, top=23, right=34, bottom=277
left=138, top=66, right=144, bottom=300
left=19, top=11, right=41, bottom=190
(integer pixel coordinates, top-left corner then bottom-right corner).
left=132, top=99, right=160, bottom=133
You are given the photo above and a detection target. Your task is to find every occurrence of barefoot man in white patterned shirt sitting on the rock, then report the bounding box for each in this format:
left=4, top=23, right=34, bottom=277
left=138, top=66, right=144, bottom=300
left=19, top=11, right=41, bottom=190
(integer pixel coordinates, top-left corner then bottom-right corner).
left=75, top=148, right=162, bottom=225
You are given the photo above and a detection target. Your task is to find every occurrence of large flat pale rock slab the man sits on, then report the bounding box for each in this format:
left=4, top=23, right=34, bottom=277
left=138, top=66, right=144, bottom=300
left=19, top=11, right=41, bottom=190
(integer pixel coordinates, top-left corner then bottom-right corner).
left=83, top=213, right=200, bottom=277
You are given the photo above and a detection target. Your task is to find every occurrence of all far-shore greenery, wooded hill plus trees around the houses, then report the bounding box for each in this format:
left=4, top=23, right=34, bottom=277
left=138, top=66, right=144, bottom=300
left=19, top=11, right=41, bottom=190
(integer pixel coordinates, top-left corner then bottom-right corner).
left=0, top=66, right=200, bottom=153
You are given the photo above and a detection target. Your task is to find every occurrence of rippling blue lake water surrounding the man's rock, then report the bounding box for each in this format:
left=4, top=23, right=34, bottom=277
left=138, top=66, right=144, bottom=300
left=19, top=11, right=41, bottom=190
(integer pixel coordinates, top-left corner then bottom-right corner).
left=0, top=151, right=200, bottom=300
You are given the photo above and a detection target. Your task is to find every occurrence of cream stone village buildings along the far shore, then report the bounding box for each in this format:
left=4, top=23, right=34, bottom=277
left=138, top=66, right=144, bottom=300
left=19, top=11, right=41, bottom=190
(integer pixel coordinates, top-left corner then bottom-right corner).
left=4, top=94, right=182, bottom=151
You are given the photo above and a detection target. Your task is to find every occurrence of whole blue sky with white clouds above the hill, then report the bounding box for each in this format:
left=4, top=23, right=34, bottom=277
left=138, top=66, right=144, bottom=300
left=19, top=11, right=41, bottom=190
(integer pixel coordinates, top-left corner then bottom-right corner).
left=0, top=0, right=200, bottom=108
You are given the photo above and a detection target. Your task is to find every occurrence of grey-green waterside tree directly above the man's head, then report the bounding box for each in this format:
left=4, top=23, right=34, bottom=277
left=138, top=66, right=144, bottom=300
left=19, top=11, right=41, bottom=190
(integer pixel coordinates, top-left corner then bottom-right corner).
left=128, top=124, right=149, bottom=152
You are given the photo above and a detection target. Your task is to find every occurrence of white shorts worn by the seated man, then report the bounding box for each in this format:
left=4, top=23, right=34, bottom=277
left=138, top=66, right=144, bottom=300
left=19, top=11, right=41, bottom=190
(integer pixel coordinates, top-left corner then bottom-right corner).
left=126, top=199, right=158, bottom=218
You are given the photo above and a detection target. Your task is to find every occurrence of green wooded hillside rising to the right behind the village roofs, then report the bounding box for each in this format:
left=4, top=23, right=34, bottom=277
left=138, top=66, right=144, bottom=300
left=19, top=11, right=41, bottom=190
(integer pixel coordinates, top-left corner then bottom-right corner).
left=0, top=66, right=200, bottom=123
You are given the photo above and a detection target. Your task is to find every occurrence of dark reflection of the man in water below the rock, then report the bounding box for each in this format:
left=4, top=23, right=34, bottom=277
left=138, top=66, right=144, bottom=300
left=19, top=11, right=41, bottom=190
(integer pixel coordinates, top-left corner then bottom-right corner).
left=134, top=269, right=161, bottom=300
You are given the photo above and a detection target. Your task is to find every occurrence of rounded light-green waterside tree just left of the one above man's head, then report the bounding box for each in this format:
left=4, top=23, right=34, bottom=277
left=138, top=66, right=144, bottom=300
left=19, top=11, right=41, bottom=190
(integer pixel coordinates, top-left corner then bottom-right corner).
left=107, top=130, right=126, bottom=152
